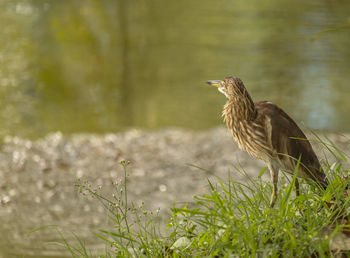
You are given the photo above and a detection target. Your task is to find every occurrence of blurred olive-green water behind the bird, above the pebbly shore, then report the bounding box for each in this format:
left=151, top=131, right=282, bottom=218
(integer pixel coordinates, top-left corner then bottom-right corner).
left=0, top=0, right=350, bottom=138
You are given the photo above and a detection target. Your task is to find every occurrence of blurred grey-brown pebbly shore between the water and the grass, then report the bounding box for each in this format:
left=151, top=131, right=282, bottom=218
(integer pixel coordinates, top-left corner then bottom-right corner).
left=0, top=127, right=350, bottom=257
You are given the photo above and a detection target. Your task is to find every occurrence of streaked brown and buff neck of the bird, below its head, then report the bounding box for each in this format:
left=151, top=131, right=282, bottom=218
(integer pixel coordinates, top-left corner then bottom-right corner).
left=222, top=95, right=257, bottom=127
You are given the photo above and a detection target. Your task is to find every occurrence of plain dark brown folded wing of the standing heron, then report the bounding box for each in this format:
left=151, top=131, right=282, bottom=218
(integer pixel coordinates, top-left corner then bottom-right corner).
left=255, top=101, right=324, bottom=180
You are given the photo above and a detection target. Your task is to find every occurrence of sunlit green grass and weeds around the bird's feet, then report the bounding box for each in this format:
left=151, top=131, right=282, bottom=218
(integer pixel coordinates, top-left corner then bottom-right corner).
left=69, top=138, right=350, bottom=257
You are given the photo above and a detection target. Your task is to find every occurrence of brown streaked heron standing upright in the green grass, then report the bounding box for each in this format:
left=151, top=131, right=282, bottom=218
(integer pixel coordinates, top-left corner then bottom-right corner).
left=206, top=76, right=329, bottom=207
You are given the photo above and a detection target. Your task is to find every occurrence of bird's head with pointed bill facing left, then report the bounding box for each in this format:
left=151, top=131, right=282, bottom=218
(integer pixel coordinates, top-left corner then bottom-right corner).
left=206, top=76, right=247, bottom=99
